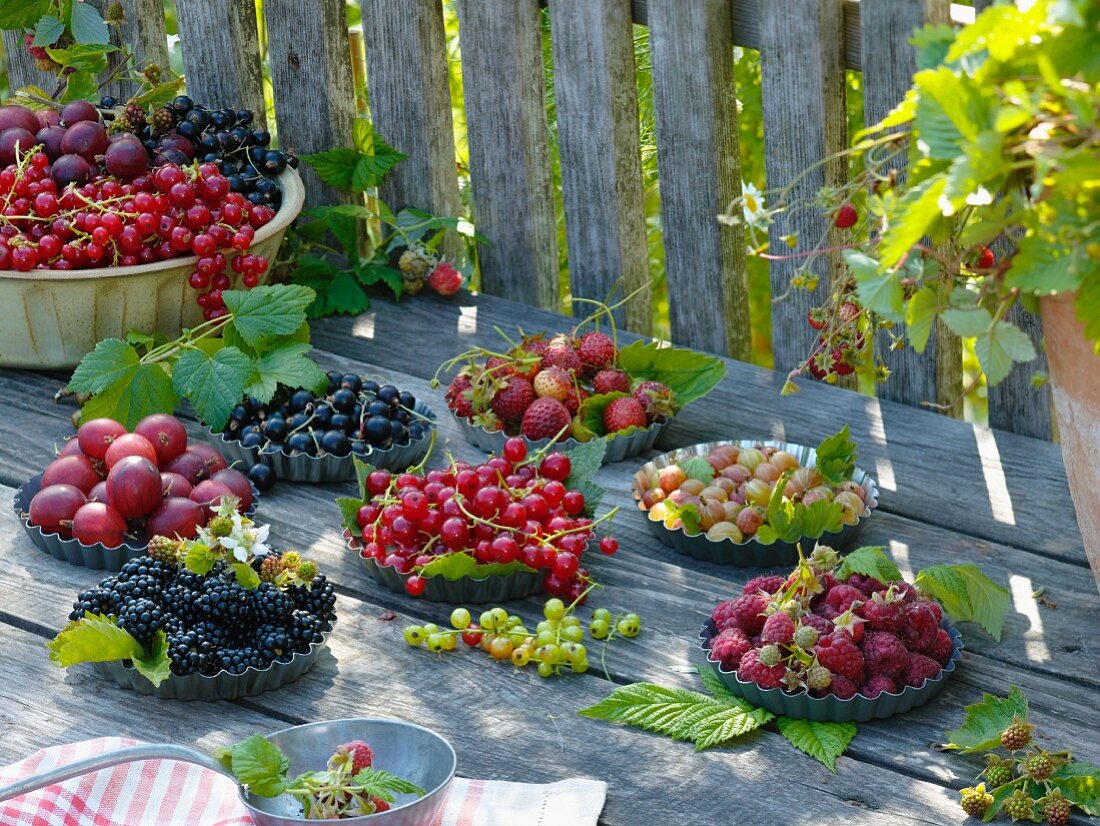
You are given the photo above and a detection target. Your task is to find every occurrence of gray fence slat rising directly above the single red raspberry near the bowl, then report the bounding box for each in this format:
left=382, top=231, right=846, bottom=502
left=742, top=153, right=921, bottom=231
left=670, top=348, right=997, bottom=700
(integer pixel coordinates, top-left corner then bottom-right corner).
left=362, top=0, right=459, bottom=216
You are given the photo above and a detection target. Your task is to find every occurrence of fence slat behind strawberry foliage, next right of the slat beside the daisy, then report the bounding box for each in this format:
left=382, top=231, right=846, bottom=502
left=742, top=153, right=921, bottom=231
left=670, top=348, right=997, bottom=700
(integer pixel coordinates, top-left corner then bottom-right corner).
left=860, top=0, right=963, bottom=415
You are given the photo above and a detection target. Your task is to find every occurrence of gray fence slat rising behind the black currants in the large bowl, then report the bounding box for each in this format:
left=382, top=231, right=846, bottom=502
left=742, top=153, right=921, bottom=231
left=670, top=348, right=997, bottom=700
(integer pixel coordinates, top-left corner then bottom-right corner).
left=176, top=0, right=266, bottom=122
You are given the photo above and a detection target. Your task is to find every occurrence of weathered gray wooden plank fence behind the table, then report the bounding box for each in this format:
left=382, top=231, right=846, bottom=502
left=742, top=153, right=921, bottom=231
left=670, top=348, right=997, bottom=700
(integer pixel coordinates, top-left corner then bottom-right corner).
left=4, top=0, right=1051, bottom=438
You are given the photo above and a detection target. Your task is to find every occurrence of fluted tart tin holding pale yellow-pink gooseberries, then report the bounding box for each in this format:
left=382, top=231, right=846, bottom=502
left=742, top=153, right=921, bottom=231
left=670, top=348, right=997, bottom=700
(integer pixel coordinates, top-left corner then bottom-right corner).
left=631, top=439, right=879, bottom=568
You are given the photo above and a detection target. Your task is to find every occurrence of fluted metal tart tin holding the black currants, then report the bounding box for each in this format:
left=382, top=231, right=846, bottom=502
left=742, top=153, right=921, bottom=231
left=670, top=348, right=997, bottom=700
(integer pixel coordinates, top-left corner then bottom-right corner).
left=210, top=401, right=436, bottom=484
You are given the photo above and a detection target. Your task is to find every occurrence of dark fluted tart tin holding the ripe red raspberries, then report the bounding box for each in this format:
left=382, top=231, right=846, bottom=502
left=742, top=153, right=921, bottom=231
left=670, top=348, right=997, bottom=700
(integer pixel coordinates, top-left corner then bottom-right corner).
left=699, top=619, right=964, bottom=723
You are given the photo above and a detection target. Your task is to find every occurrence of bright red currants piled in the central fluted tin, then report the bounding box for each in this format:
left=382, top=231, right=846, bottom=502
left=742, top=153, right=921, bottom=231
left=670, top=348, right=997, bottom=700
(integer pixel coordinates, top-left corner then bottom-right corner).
left=347, top=437, right=618, bottom=601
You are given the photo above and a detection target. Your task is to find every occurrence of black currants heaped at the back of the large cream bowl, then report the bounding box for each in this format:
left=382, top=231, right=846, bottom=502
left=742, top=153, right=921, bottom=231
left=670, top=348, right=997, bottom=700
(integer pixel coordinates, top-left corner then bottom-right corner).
left=100, top=95, right=298, bottom=209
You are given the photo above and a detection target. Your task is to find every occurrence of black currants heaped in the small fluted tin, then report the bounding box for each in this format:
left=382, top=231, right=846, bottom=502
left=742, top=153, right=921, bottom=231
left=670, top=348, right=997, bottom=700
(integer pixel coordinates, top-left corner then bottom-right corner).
left=223, top=373, right=431, bottom=468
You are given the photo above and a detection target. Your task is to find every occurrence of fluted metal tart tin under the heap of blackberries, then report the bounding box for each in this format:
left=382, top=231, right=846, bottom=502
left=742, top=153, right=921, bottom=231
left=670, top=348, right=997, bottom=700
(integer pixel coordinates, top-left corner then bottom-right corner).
left=91, top=634, right=328, bottom=701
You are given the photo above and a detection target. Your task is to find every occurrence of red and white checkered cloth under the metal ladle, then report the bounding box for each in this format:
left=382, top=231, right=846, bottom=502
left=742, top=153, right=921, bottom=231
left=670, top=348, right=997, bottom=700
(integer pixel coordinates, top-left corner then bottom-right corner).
left=0, top=737, right=607, bottom=826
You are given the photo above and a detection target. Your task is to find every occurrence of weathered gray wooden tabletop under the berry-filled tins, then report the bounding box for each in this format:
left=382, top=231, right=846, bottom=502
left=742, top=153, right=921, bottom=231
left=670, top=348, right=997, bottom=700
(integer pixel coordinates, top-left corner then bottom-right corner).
left=0, top=295, right=1100, bottom=826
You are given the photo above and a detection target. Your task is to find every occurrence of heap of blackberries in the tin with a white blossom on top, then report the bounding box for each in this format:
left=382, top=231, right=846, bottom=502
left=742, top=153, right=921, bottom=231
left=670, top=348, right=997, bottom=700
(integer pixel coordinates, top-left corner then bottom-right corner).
left=69, top=557, right=336, bottom=676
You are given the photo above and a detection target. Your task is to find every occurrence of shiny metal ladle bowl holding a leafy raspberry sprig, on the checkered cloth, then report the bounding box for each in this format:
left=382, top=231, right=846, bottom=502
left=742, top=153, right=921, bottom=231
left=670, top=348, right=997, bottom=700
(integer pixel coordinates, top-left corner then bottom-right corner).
left=241, top=718, right=458, bottom=826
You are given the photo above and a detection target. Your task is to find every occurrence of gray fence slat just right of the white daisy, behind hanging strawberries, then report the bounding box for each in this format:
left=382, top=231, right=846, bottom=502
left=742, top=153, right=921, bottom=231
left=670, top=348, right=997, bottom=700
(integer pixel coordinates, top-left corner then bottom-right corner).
left=760, top=0, right=847, bottom=372
